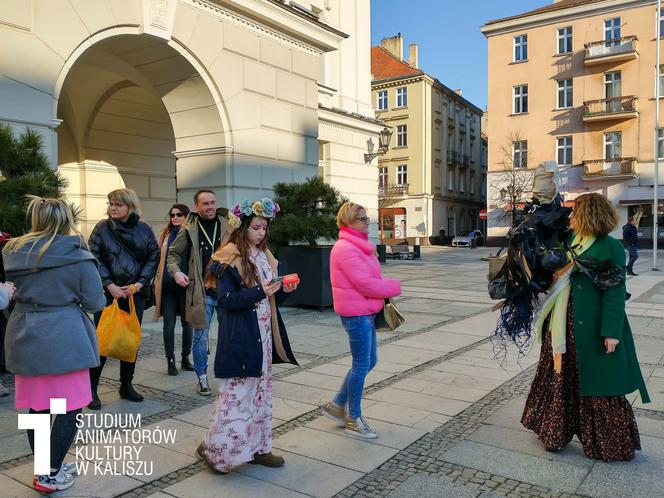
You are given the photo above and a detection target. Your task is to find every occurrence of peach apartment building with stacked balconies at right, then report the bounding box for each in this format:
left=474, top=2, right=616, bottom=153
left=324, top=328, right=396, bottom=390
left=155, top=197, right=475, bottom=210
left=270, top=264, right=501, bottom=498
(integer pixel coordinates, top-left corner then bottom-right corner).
left=482, top=0, right=664, bottom=238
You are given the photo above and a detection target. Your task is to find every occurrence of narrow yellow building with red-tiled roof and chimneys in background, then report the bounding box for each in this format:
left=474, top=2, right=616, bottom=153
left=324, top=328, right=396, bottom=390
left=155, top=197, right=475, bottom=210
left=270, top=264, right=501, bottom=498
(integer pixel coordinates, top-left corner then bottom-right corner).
left=371, top=34, right=486, bottom=244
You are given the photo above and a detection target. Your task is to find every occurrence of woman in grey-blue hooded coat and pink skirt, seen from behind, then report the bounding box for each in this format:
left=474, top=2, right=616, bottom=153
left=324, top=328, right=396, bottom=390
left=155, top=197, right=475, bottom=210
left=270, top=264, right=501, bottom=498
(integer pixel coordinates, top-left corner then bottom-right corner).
left=3, top=196, right=105, bottom=492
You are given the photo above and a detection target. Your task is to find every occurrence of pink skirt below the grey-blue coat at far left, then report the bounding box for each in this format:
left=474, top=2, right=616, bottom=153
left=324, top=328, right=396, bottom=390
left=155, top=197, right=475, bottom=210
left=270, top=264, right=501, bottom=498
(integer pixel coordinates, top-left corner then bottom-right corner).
left=14, top=368, right=92, bottom=412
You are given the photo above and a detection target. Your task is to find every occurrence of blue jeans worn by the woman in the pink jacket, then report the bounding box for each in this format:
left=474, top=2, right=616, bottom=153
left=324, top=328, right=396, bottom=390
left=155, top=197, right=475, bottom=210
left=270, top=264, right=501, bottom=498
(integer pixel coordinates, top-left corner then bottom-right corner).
left=334, top=315, right=378, bottom=419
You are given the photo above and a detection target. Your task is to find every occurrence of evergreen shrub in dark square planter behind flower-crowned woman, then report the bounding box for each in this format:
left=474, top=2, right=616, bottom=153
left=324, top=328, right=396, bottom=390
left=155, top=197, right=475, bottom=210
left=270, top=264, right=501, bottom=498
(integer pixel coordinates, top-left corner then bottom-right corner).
left=270, top=177, right=346, bottom=309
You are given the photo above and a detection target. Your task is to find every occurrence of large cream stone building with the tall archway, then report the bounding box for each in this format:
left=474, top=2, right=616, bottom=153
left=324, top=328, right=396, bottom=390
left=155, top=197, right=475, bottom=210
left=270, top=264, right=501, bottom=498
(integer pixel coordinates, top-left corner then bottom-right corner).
left=0, top=0, right=382, bottom=237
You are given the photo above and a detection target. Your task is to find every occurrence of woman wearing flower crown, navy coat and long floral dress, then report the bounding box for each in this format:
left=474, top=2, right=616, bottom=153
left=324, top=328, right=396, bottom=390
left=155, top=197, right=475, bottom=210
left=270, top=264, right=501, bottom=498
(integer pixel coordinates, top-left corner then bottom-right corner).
left=197, top=198, right=297, bottom=473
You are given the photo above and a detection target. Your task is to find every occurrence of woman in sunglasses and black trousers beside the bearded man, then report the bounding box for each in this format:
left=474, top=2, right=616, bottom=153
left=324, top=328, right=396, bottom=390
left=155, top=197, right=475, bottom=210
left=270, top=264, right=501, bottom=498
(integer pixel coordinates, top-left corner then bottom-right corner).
left=153, top=204, right=194, bottom=375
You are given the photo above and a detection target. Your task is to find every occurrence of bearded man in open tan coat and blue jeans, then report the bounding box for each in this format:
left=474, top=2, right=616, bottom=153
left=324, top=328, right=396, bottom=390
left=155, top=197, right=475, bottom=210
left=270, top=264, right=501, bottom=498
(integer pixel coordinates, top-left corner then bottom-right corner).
left=166, top=189, right=230, bottom=396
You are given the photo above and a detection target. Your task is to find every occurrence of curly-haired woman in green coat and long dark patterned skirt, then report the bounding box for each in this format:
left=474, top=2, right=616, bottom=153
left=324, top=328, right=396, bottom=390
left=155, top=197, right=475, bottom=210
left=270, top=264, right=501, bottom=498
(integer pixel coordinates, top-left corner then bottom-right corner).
left=521, top=193, right=650, bottom=461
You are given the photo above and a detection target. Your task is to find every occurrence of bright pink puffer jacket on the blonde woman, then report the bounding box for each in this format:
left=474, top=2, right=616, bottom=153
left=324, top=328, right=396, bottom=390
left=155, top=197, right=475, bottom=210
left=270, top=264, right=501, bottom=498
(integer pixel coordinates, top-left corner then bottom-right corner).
left=330, top=227, right=401, bottom=316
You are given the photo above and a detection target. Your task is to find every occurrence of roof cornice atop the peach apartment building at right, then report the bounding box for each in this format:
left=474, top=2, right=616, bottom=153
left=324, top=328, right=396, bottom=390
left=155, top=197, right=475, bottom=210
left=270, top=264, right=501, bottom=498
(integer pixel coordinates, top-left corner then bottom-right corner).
left=480, top=0, right=656, bottom=38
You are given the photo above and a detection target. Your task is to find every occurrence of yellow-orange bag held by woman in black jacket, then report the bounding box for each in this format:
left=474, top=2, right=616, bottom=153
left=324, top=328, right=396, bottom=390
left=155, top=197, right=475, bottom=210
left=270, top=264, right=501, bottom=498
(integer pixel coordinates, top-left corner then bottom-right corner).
left=97, top=296, right=141, bottom=363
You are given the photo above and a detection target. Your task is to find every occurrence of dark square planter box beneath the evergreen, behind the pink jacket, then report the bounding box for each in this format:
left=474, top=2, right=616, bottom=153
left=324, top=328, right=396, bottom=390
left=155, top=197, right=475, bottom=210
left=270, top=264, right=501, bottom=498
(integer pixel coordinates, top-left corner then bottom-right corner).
left=278, top=246, right=332, bottom=309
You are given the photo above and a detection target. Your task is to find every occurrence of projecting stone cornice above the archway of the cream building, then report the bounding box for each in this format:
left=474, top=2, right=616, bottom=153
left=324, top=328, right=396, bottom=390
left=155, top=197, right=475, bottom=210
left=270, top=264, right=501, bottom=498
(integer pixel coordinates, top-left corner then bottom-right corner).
left=191, top=0, right=348, bottom=54
